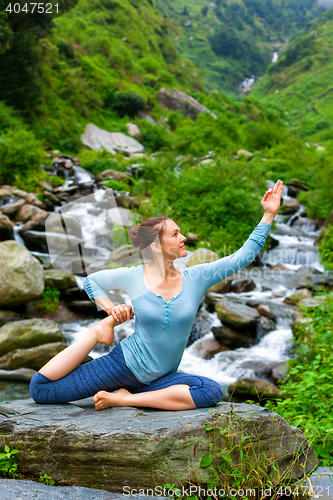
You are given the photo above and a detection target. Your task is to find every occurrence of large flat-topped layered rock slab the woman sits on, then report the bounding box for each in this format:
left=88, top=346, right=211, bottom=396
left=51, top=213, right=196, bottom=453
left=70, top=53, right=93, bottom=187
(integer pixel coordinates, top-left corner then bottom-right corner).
left=0, top=398, right=318, bottom=493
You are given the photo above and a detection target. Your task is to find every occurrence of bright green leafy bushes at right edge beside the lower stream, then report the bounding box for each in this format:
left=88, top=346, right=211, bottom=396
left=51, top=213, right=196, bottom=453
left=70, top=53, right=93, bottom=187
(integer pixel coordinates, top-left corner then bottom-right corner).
left=265, top=291, right=333, bottom=465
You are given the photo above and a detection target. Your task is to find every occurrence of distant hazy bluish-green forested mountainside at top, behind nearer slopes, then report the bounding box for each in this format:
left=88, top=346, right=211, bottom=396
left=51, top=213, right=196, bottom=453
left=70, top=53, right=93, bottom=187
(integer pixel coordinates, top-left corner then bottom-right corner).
left=156, top=0, right=324, bottom=92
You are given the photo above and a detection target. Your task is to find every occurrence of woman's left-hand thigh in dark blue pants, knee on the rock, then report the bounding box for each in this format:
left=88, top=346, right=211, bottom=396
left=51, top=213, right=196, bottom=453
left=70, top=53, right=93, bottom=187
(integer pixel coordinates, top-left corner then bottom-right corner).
left=30, top=344, right=144, bottom=404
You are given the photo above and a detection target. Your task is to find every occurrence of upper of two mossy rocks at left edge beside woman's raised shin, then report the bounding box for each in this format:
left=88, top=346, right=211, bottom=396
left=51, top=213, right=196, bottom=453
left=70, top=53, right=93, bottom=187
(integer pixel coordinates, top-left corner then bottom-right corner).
left=0, top=319, right=63, bottom=356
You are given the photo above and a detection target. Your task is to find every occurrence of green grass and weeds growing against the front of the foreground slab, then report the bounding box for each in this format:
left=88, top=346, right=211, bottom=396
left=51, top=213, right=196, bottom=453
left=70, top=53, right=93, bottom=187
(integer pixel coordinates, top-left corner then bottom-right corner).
left=163, top=408, right=316, bottom=500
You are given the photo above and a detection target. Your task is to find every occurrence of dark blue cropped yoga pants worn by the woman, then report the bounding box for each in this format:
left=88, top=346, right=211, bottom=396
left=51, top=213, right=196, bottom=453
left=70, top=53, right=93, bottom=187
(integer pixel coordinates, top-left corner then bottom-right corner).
left=30, top=344, right=222, bottom=408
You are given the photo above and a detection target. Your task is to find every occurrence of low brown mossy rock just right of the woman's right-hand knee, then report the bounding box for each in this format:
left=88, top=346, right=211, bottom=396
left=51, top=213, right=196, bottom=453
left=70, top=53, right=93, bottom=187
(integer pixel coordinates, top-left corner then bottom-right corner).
left=228, top=377, right=285, bottom=400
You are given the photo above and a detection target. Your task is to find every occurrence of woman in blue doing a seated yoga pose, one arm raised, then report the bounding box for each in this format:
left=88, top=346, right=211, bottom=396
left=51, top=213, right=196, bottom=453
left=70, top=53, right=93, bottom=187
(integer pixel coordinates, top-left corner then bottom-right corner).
left=30, top=180, right=283, bottom=410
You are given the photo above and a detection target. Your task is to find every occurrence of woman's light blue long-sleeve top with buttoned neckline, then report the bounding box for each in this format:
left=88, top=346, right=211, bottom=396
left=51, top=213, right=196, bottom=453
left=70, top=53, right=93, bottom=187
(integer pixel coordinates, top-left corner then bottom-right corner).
left=83, top=222, right=271, bottom=384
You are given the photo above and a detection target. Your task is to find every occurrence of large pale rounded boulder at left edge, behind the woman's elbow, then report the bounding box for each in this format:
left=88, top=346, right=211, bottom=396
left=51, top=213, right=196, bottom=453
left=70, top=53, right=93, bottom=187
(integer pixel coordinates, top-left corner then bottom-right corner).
left=0, top=240, right=44, bottom=307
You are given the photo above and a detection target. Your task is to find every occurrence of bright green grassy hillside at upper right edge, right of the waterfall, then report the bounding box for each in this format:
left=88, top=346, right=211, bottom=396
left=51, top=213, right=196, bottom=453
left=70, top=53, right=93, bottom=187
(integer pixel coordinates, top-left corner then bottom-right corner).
left=253, top=9, right=333, bottom=150
